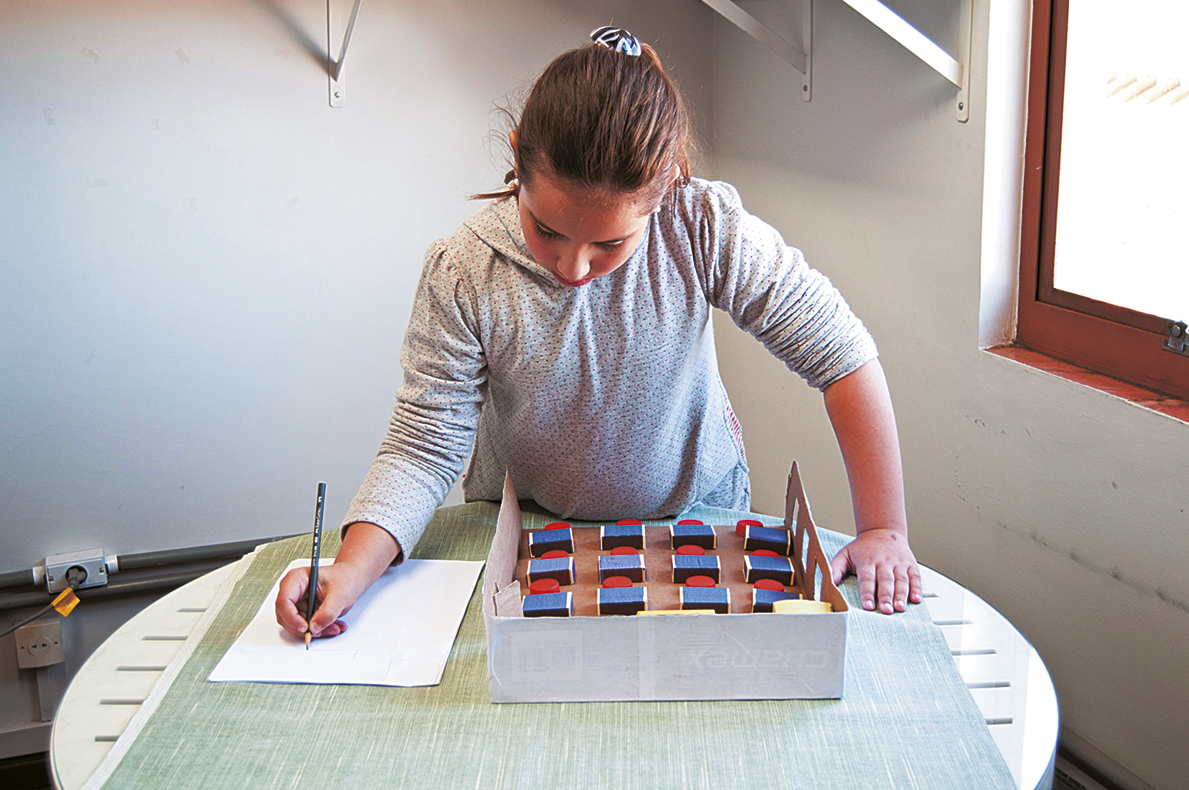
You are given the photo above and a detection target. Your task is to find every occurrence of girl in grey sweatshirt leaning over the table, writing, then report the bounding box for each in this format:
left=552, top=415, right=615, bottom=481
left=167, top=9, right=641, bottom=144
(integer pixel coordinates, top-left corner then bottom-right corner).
left=276, top=27, right=920, bottom=637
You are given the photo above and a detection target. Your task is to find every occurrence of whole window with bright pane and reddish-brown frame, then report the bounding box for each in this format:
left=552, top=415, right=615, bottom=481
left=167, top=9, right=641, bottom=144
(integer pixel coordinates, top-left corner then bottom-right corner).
left=1017, top=0, right=1189, bottom=400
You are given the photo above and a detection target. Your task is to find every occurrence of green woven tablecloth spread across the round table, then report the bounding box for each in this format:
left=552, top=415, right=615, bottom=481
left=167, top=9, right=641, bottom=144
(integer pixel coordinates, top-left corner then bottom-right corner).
left=96, top=502, right=1014, bottom=790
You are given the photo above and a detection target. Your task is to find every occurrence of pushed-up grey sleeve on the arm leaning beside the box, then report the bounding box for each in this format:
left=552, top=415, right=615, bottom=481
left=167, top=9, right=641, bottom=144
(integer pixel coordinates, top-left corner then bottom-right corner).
left=690, top=183, right=877, bottom=389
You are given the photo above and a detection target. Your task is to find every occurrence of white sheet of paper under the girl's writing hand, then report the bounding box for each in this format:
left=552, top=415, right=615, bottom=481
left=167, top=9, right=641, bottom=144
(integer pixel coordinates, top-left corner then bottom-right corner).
left=208, top=559, right=483, bottom=686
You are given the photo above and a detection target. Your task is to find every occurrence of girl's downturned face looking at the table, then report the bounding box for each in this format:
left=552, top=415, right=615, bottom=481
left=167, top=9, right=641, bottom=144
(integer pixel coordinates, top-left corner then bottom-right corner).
left=520, top=173, right=650, bottom=288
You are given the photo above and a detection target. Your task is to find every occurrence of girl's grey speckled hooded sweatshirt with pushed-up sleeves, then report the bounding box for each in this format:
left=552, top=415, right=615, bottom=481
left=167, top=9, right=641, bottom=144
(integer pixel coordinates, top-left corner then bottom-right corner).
left=344, top=178, right=876, bottom=554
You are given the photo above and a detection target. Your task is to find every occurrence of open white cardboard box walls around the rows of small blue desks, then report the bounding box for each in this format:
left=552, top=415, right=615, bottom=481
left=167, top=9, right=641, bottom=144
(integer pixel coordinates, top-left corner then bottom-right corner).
left=483, top=462, right=847, bottom=702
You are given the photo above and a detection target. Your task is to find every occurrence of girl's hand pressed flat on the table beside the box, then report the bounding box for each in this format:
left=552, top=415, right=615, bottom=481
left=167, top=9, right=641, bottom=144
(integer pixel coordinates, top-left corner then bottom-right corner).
left=830, top=528, right=921, bottom=614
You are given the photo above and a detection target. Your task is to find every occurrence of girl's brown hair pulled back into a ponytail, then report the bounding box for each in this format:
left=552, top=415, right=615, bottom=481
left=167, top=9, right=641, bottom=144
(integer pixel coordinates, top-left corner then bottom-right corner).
left=476, top=38, right=693, bottom=207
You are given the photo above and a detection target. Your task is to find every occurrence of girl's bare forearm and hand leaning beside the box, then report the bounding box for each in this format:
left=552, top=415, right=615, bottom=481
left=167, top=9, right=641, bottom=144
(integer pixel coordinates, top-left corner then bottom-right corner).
left=824, top=359, right=921, bottom=614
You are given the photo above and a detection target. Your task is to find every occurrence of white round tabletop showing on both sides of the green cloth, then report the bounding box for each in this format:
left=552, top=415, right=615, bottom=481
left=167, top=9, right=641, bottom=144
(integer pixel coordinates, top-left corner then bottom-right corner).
left=50, top=557, right=1058, bottom=790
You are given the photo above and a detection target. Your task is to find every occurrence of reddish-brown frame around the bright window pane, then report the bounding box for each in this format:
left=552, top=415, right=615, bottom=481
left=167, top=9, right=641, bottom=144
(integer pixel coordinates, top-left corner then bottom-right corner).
left=1015, top=0, right=1189, bottom=400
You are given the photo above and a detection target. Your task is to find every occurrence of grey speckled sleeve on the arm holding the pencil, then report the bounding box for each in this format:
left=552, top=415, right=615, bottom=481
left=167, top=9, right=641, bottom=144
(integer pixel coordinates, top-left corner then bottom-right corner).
left=344, top=242, right=487, bottom=558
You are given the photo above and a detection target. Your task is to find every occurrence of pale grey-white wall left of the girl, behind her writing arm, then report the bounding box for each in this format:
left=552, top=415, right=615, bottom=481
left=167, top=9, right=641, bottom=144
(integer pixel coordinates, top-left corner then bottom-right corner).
left=0, top=0, right=712, bottom=757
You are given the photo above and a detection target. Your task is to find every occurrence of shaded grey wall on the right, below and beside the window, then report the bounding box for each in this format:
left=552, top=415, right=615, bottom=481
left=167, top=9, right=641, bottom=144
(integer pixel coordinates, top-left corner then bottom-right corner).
left=715, top=0, right=1189, bottom=788
